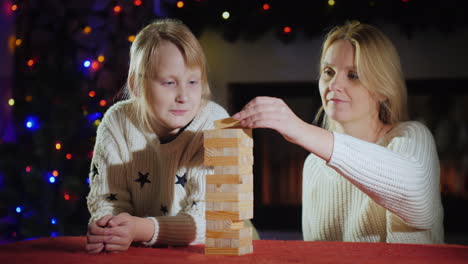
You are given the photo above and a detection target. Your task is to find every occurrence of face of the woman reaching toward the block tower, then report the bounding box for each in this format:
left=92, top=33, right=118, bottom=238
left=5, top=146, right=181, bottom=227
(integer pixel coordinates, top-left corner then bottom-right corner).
left=319, top=40, right=378, bottom=125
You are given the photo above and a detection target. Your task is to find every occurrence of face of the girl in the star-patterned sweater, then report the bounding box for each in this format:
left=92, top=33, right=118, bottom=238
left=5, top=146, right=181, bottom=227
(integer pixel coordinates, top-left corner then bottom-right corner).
left=150, top=41, right=202, bottom=137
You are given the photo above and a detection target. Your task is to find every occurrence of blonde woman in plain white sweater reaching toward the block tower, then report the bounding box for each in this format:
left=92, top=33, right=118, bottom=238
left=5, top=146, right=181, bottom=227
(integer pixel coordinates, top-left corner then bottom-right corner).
left=233, top=22, right=444, bottom=243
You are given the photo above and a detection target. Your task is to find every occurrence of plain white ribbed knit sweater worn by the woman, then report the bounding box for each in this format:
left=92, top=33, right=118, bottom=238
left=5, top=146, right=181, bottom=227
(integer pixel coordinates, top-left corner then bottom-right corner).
left=302, top=122, right=444, bottom=244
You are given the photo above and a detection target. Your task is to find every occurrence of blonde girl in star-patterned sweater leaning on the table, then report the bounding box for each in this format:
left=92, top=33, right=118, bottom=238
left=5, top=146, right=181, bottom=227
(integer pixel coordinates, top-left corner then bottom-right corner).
left=86, top=19, right=256, bottom=253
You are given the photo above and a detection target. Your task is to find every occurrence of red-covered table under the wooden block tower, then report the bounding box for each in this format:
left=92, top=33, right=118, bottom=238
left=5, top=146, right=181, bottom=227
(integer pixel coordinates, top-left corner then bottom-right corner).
left=0, top=237, right=468, bottom=264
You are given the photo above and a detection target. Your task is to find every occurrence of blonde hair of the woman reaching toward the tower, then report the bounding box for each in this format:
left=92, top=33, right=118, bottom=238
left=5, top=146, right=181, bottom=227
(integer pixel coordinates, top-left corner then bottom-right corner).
left=315, top=21, right=408, bottom=130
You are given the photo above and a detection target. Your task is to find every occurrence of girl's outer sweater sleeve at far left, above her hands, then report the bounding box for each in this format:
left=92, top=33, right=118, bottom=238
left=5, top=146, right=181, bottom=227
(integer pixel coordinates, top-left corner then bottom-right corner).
left=87, top=123, right=133, bottom=223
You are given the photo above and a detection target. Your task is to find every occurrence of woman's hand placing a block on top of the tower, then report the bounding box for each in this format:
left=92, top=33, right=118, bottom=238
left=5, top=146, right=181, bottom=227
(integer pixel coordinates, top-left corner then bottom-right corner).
left=232, top=97, right=306, bottom=144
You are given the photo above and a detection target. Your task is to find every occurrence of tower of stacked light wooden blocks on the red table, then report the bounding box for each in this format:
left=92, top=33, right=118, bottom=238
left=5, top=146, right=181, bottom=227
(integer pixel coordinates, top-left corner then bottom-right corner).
left=204, top=118, right=253, bottom=255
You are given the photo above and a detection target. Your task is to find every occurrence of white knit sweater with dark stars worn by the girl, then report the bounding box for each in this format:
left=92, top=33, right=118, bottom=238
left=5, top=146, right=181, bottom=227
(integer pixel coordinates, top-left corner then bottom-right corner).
left=87, top=100, right=228, bottom=245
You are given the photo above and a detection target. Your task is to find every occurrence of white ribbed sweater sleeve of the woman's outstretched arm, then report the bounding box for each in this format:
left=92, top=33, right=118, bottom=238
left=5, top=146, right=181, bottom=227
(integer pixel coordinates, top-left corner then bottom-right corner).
left=328, top=122, right=440, bottom=229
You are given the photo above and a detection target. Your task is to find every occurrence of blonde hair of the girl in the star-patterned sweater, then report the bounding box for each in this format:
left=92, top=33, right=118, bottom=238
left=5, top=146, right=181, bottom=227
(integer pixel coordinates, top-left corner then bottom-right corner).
left=125, top=19, right=211, bottom=129
